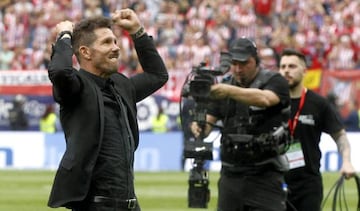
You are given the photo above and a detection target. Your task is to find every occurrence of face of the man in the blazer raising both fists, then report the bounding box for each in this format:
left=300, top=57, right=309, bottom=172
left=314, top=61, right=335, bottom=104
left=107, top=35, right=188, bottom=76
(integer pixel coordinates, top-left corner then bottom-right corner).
left=89, top=28, right=120, bottom=75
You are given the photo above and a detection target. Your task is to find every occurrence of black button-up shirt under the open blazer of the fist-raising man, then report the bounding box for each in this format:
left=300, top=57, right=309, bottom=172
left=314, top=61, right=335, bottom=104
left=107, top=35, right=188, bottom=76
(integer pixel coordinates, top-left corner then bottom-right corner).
left=84, top=73, right=134, bottom=199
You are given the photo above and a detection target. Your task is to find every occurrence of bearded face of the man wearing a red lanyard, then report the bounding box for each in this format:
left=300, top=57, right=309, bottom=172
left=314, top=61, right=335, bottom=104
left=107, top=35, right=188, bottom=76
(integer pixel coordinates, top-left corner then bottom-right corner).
left=279, top=55, right=306, bottom=89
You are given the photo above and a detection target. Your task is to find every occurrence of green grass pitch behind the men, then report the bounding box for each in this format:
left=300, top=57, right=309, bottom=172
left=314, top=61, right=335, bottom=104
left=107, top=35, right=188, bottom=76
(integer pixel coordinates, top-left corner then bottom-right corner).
left=0, top=170, right=358, bottom=211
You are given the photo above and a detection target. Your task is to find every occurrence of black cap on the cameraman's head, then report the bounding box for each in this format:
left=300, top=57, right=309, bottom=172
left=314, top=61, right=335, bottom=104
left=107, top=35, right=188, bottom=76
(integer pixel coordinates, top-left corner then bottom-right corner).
left=229, top=37, right=257, bottom=62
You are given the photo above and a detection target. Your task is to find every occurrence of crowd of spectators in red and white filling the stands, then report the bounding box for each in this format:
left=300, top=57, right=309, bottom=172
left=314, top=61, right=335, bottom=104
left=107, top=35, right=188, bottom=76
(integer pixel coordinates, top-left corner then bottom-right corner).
left=0, top=0, right=360, bottom=74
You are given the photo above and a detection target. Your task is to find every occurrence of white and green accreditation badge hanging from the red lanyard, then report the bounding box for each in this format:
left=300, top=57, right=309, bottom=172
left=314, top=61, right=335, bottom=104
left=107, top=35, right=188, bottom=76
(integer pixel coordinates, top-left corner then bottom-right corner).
left=285, top=140, right=305, bottom=169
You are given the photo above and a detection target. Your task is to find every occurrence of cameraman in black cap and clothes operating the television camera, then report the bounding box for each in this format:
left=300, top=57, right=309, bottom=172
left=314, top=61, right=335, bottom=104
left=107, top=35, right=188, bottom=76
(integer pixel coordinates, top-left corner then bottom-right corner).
left=191, top=37, right=290, bottom=211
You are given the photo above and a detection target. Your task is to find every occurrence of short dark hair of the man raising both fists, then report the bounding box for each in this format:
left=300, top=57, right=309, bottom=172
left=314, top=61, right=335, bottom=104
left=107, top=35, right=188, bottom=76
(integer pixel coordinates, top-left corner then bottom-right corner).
left=71, top=16, right=112, bottom=60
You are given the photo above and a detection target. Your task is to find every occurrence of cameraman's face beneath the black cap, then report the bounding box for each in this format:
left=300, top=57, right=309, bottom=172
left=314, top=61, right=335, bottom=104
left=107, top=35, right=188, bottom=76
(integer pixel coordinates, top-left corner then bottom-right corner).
left=231, top=57, right=257, bottom=86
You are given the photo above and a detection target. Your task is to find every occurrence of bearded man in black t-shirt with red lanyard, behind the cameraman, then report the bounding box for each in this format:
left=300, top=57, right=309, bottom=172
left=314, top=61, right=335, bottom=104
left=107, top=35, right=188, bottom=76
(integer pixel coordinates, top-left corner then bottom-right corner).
left=279, top=49, right=355, bottom=211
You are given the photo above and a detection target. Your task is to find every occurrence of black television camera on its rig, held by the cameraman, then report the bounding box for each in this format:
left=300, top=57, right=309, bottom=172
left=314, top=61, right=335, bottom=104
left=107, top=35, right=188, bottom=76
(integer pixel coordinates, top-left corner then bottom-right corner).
left=180, top=52, right=231, bottom=208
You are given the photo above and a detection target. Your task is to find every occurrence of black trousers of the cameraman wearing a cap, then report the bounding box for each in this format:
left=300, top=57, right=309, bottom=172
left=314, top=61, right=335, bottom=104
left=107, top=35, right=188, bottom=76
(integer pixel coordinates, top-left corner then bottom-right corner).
left=217, top=171, right=287, bottom=211
